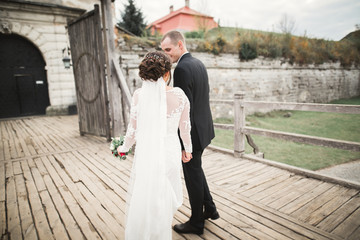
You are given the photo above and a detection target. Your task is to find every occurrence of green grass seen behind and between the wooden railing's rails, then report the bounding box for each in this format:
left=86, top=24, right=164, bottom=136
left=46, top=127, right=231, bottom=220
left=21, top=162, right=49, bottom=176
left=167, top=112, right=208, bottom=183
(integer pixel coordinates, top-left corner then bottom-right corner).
left=212, top=97, right=360, bottom=170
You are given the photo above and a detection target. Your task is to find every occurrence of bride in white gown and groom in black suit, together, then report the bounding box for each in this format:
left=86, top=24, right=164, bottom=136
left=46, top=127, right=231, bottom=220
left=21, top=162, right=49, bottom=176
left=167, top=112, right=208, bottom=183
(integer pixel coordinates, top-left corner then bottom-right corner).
left=118, top=31, right=219, bottom=240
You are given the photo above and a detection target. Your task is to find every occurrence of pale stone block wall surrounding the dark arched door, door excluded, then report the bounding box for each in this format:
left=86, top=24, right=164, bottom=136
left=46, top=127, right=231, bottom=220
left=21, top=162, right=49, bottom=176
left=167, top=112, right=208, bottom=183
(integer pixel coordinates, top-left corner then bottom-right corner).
left=0, top=2, right=88, bottom=115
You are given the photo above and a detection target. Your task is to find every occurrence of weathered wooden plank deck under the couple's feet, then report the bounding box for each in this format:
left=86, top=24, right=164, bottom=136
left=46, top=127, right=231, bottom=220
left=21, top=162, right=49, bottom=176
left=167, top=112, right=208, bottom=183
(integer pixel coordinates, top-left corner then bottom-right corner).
left=0, top=116, right=360, bottom=240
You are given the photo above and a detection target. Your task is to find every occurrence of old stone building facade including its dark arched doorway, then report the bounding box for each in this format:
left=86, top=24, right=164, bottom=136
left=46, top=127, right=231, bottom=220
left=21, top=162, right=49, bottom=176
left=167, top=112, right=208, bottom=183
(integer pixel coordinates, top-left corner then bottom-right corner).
left=0, top=0, right=100, bottom=118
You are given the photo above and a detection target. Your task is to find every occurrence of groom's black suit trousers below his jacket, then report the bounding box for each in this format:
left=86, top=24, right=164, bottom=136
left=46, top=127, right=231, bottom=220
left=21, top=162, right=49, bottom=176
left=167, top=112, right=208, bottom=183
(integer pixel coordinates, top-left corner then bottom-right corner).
left=183, top=150, right=216, bottom=229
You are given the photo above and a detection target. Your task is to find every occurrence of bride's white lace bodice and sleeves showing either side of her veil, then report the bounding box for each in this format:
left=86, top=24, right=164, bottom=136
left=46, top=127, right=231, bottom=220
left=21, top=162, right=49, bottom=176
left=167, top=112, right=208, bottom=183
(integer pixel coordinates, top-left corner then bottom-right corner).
left=121, top=87, right=192, bottom=153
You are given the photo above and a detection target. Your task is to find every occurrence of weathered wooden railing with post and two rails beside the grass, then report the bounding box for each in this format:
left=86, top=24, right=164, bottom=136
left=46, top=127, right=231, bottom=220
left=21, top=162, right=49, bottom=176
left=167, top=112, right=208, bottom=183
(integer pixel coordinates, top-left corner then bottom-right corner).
left=211, top=92, right=360, bottom=157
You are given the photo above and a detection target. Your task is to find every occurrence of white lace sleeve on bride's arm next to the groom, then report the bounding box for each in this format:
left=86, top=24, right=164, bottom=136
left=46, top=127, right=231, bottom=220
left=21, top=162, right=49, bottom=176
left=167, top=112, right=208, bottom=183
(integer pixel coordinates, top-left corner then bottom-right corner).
left=179, top=94, right=192, bottom=153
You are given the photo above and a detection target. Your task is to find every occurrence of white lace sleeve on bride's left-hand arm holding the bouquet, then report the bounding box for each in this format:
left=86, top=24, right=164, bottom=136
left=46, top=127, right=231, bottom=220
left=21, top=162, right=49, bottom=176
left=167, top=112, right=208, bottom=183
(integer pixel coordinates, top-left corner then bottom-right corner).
left=119, top=91, right=139, bottom=152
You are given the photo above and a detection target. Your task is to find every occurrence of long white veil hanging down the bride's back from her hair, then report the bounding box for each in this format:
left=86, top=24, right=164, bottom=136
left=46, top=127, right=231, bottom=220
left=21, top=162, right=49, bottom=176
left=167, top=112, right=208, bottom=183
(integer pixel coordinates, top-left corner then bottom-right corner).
left=125, top=78, right=172, bottom=240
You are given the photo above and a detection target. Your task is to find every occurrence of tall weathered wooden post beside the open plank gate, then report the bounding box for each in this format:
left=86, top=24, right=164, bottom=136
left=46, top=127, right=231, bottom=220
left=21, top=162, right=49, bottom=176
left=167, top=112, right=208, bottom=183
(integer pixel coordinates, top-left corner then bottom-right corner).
left=101, top=0, right=125, bottom=137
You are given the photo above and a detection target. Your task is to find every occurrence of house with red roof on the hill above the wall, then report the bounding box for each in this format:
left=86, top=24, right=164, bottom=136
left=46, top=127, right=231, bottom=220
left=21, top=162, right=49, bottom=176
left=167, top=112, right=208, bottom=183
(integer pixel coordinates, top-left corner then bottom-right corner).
left=147, top=0, right=218, bottom=35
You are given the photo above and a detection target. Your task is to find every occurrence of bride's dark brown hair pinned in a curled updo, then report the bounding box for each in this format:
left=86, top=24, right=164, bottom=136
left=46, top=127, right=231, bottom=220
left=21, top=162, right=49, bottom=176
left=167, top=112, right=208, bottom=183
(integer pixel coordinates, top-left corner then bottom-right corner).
left=139, top=51, right=171, bottom=85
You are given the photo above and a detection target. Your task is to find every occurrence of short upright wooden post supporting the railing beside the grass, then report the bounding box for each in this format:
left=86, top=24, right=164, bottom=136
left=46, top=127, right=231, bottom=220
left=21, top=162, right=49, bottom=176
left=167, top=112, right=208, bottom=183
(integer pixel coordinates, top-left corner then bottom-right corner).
left=234, top=92, right=245, bottom=157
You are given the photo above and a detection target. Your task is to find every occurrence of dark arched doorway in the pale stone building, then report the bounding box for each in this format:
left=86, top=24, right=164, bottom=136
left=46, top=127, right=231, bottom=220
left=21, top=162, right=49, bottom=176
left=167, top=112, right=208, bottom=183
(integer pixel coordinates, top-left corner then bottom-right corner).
left=0, top=33, right=50, bottom=118
